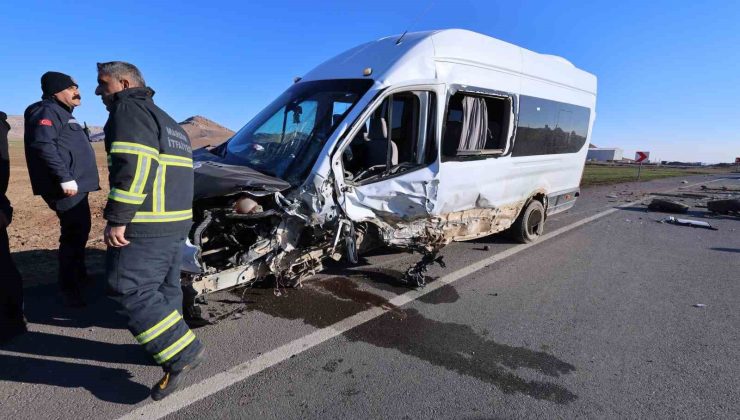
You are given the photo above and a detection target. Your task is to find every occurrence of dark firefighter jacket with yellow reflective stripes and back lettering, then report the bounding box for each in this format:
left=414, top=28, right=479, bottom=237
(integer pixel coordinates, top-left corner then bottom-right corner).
left=103, top=88, right=193, bottom=237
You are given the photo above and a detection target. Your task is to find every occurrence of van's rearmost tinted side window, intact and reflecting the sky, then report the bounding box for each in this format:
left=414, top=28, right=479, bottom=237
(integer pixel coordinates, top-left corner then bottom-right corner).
left=511, top=95, right=591, bottom=156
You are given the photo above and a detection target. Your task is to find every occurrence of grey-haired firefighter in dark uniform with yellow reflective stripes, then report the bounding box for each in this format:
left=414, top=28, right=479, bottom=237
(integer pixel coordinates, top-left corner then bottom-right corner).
left=95, top=61, right=204, bottom=400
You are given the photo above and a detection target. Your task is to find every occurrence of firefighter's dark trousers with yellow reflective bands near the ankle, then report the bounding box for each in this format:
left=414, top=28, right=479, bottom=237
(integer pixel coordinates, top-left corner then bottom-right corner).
left=106, top=235, right=202, bottom=371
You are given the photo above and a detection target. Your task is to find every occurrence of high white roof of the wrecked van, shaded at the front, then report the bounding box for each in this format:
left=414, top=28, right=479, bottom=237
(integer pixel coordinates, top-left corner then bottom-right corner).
left=302, top=29, right=596, bottom=95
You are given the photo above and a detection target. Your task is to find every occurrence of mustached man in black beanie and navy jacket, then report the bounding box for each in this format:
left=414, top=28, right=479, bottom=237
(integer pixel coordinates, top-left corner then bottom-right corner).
left=24, top=71, right=100, bottom=307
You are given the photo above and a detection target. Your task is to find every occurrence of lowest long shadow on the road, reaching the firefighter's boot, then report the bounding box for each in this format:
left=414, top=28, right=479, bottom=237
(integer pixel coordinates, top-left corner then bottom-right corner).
left=0, top=354, right=150, bottom=406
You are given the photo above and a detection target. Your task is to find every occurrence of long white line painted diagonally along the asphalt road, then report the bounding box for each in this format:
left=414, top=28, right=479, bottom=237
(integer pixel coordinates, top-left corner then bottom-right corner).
left=120, top=178, right=724, bottom=420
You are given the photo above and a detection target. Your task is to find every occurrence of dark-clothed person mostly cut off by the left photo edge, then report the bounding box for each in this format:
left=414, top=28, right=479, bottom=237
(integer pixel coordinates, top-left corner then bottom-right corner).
left=0, top=112, right=26, bottom=342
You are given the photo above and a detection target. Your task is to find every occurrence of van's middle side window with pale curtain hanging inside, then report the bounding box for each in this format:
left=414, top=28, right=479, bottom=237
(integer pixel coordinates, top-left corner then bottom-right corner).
left=442, top=92, right=511, bottom=158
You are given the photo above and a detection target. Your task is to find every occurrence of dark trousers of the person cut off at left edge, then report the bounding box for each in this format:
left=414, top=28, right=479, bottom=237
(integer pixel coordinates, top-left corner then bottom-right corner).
left=0, top=228, right=23, bottom=324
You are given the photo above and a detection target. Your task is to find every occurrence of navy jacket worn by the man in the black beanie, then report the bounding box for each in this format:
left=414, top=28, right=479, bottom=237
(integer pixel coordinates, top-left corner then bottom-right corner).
left=23, top=99, right=100, bottom=199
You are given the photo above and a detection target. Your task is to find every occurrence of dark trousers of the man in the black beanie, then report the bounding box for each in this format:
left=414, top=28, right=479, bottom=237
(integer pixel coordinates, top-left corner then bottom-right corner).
left=44, top=193, right=91, bottom=292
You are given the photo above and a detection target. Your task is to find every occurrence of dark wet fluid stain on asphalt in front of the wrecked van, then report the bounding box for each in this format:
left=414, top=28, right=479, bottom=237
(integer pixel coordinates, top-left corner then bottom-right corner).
left=234, top=277, right=578, bottom=404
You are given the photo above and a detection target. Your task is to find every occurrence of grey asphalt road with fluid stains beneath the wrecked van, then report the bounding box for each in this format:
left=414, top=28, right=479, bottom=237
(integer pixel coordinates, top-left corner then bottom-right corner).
left=0, top=176, right=740, bottom=419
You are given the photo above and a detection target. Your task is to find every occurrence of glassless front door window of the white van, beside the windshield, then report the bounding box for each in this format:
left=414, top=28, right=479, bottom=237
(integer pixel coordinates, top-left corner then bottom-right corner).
left=342, top=91, right=437, bottom=183
